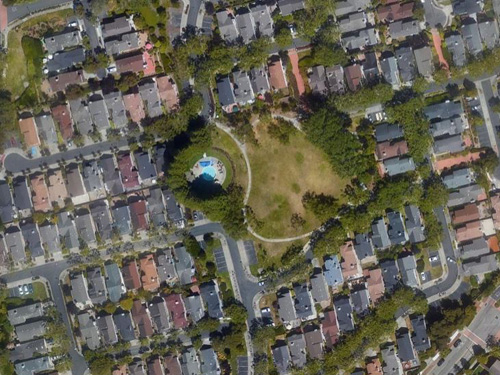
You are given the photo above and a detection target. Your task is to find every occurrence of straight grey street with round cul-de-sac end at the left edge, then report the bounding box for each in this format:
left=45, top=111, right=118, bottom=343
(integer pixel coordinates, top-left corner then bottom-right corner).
left=4, top=138, right=128, bottom=173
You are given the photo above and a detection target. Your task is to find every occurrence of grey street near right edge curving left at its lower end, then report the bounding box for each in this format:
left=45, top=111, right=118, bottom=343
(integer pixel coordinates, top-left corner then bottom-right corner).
left=423, top=207, right=459, bottom=298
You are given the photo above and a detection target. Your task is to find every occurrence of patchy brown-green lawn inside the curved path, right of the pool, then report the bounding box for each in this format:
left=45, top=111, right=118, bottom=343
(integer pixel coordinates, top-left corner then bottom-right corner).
left=248, top=124, right=346, bottom=238
